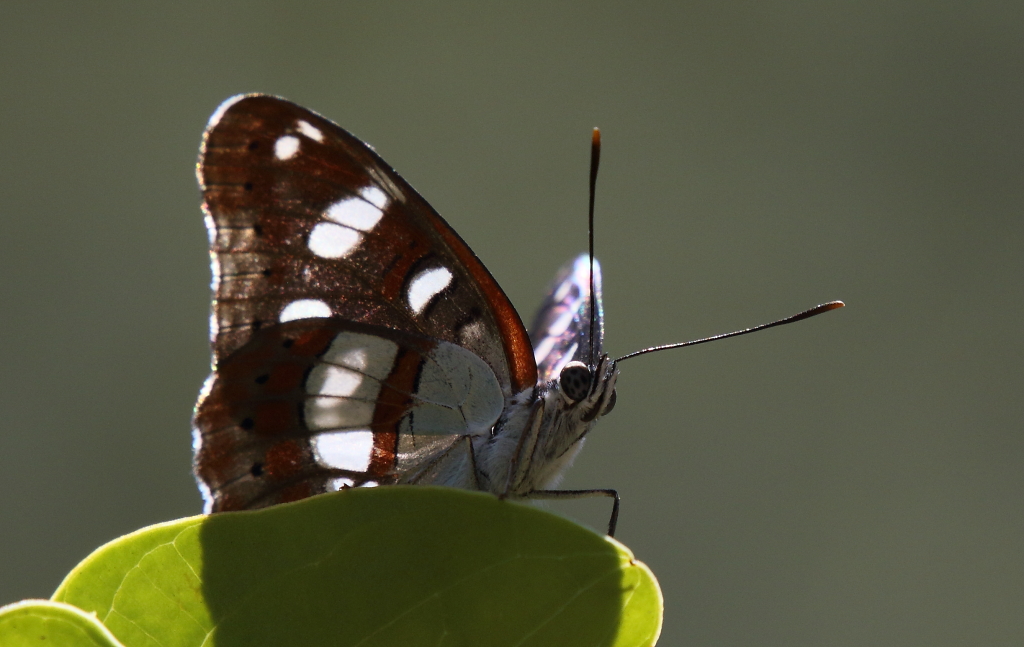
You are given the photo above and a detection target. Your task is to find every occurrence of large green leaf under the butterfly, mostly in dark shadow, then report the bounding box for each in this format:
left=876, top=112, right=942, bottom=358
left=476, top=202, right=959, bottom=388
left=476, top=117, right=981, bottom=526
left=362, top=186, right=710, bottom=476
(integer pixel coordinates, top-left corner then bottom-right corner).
left=53, top=486, right=662, bottom=647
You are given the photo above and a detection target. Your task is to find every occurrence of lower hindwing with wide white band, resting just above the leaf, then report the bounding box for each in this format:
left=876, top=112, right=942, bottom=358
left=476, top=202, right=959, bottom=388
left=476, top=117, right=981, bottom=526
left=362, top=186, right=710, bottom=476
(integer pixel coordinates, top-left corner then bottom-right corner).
left=194, top=317, right=504, bottom=512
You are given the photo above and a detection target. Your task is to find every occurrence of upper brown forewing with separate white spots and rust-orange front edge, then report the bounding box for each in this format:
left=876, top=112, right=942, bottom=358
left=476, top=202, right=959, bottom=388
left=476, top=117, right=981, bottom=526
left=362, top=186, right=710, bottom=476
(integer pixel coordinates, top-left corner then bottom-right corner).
left=198, top=95, right=537, bottom=395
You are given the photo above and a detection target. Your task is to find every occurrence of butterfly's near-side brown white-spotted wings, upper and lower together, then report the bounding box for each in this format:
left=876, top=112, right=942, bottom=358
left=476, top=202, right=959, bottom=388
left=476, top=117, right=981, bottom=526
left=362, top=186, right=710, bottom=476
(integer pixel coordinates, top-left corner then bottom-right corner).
left=194, top=95, right=538, bottom=511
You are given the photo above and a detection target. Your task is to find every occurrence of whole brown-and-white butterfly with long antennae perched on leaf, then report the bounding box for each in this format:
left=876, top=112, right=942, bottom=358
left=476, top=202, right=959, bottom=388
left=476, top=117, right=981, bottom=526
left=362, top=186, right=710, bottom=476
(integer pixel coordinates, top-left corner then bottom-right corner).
left=193, top=94, right=843, bottom=534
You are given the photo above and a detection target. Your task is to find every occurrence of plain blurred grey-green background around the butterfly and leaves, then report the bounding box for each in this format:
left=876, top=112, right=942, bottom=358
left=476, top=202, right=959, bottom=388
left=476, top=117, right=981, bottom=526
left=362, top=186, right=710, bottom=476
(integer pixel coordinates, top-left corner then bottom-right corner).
left=0, top=0, right=1024, bottom=646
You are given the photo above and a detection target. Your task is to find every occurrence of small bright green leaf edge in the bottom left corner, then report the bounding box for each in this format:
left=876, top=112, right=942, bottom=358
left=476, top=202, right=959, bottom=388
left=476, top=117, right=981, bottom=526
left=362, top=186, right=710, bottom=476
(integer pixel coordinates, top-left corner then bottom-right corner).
left=0, top=600, right=121, bottom=647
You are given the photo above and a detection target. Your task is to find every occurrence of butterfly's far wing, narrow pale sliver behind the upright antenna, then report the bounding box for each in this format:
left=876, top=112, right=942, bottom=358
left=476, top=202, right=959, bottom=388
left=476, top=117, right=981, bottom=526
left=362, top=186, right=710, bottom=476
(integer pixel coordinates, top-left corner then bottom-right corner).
left=530, top=254, right=604, bottom=382
